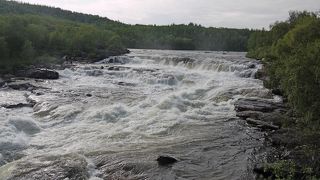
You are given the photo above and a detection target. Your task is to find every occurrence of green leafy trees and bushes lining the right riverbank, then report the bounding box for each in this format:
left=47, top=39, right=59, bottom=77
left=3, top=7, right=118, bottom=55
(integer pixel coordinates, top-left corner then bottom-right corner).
left=247, top=11, right=320, bottom=179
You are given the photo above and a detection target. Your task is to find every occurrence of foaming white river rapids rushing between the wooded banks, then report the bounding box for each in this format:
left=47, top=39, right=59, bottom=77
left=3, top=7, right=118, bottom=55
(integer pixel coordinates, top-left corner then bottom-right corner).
left=0, top=50, right=272, bottom=180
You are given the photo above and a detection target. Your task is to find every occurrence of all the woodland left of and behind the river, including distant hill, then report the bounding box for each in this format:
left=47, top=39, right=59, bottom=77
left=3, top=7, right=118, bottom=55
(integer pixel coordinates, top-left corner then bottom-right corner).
left=0, top=0, right=252, bottom=72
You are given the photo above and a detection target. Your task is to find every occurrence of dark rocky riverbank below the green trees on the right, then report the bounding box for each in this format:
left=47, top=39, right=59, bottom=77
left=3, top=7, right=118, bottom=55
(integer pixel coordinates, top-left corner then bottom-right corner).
left=235, top=65, right=320, bottom=179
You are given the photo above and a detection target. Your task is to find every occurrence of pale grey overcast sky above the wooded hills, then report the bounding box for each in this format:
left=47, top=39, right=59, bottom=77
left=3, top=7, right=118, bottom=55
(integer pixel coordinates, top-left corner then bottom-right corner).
left=18, top=0, right=320, bottom=28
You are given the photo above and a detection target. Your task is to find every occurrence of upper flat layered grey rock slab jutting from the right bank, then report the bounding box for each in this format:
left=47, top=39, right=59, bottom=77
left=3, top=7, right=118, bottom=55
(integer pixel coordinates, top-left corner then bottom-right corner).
left=234, top=99, right=284, bottom=112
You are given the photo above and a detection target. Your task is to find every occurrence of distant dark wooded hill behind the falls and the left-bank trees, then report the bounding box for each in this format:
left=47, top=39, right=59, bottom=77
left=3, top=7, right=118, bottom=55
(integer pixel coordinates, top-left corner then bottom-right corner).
left=0, top=0, right=254, bottom=54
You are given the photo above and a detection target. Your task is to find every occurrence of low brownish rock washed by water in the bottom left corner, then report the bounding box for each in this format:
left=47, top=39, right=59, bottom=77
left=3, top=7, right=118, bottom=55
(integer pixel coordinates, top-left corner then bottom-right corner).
left=0, top=154, right=90, bottom=180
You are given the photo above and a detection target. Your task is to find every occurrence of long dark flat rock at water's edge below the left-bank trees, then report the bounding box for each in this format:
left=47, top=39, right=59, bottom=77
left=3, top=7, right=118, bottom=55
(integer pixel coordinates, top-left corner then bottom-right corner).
left=15, top=69, right=59, bottom=79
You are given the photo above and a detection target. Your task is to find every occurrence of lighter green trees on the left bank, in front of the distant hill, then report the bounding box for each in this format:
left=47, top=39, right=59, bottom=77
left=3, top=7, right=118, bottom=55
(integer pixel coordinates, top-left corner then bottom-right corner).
left=0, top=15, right=126, bottom=73
